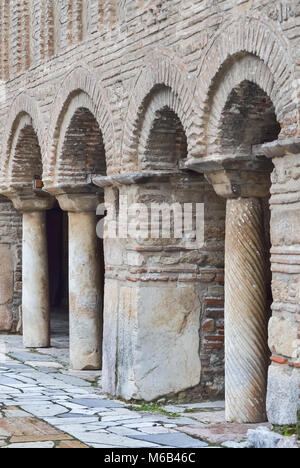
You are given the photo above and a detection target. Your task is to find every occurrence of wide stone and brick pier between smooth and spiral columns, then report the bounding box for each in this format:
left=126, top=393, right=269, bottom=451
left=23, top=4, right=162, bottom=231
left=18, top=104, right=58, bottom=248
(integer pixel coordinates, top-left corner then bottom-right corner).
left=93, top=172, right=224, bottom=401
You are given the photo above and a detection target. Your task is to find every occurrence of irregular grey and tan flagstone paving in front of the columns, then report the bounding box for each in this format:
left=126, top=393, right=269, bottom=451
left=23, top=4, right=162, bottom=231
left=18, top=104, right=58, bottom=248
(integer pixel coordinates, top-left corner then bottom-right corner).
left=0, top=316, right=258, bottom=448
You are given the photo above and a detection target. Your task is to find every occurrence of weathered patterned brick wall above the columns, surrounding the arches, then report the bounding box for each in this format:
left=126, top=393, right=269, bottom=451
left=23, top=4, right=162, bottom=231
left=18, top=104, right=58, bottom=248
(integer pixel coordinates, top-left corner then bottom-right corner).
left=0, top=0, right=300, bottom=400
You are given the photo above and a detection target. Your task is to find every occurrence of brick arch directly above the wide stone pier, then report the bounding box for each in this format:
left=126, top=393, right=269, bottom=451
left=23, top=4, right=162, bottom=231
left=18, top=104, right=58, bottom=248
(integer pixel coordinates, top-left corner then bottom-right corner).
left=122, top=52, right=195, bottom=172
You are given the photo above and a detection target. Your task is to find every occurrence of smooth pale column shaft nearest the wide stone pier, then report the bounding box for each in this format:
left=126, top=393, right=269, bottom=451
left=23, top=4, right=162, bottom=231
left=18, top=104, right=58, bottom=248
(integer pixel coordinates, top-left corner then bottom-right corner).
left=69, top=212, right=102, bottom=370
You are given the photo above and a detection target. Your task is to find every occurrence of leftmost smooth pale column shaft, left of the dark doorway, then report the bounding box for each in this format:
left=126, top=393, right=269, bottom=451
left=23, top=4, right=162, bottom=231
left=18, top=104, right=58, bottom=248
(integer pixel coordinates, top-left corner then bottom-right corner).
left=22, top=211, right=50, bottom=348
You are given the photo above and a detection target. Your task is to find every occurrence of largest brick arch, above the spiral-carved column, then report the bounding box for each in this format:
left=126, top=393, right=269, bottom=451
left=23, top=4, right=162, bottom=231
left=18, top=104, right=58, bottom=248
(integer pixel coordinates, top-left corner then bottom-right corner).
left=193, top=15, right=299, bottom=156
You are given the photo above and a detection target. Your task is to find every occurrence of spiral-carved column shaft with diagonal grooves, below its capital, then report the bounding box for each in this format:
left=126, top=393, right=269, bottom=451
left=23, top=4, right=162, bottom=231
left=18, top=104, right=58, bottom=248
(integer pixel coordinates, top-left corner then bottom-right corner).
left=225, top=198, right=268, bottom=423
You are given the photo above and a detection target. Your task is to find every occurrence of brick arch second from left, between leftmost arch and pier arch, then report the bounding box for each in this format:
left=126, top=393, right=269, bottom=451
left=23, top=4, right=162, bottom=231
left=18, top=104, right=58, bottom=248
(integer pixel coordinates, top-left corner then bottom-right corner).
left=45, top=67, right=115, bottom=185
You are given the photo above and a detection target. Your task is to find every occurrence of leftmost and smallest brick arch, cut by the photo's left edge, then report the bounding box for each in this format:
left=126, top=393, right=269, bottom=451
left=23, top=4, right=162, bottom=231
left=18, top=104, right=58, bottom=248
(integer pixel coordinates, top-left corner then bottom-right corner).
left=0, top=94, right=46, bottom=187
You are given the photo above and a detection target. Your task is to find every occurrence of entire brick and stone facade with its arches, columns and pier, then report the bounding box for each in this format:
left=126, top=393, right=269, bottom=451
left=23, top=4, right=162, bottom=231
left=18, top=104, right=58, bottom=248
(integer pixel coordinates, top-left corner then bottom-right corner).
left=0, top=0, right=300, bottom=423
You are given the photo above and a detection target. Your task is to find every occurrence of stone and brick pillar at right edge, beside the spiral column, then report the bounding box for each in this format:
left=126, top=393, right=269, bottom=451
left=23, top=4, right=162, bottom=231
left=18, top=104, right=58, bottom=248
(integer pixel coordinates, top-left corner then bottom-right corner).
left=263, top=138, right=300, bottom=425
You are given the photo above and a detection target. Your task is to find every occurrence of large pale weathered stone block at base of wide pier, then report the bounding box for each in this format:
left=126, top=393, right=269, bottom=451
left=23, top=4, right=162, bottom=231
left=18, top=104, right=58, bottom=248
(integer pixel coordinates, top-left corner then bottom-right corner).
left=118, top=284, right=201, bottom=400
